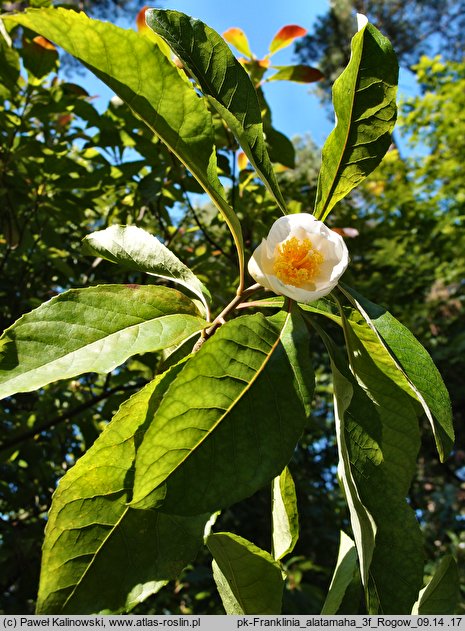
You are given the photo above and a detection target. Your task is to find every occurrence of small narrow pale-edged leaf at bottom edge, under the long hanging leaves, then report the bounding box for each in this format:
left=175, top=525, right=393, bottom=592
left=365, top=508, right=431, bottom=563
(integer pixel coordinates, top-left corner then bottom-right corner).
left=321, top=530, right=360, bottom=616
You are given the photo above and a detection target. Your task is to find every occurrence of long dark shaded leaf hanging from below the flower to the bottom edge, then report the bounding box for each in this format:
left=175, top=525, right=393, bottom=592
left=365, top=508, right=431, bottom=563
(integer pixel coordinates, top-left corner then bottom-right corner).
left=316, top=312, right=424, bottom=614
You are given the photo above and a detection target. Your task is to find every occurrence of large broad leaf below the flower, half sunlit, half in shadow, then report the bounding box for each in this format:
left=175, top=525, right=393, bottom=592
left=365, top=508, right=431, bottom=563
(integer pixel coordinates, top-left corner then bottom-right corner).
left=133, top=311, right=314, bottom=514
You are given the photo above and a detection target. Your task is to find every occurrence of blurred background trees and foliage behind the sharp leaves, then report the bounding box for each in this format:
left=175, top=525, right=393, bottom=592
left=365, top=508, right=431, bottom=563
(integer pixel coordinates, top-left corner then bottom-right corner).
left=0, top=2, right=465, bottom=613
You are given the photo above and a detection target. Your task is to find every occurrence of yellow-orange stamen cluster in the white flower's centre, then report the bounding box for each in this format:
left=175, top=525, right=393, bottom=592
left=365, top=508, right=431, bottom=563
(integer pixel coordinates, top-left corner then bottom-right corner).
left=273, top=237, right=324, bottom=287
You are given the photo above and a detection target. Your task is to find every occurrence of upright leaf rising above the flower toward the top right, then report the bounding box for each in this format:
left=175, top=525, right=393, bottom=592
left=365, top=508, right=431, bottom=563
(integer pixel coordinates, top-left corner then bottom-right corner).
left=315, top=24, right=398, bottom=221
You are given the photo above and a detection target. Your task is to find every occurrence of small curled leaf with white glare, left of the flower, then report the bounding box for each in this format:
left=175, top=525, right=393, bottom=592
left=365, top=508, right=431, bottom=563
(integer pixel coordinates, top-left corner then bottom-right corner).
left=83, top=226, right=211, bottom=313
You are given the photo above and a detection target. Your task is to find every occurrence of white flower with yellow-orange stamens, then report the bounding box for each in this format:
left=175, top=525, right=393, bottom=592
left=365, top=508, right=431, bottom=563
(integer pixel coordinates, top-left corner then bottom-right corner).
left=249, top=213, right=349, bottom=303
